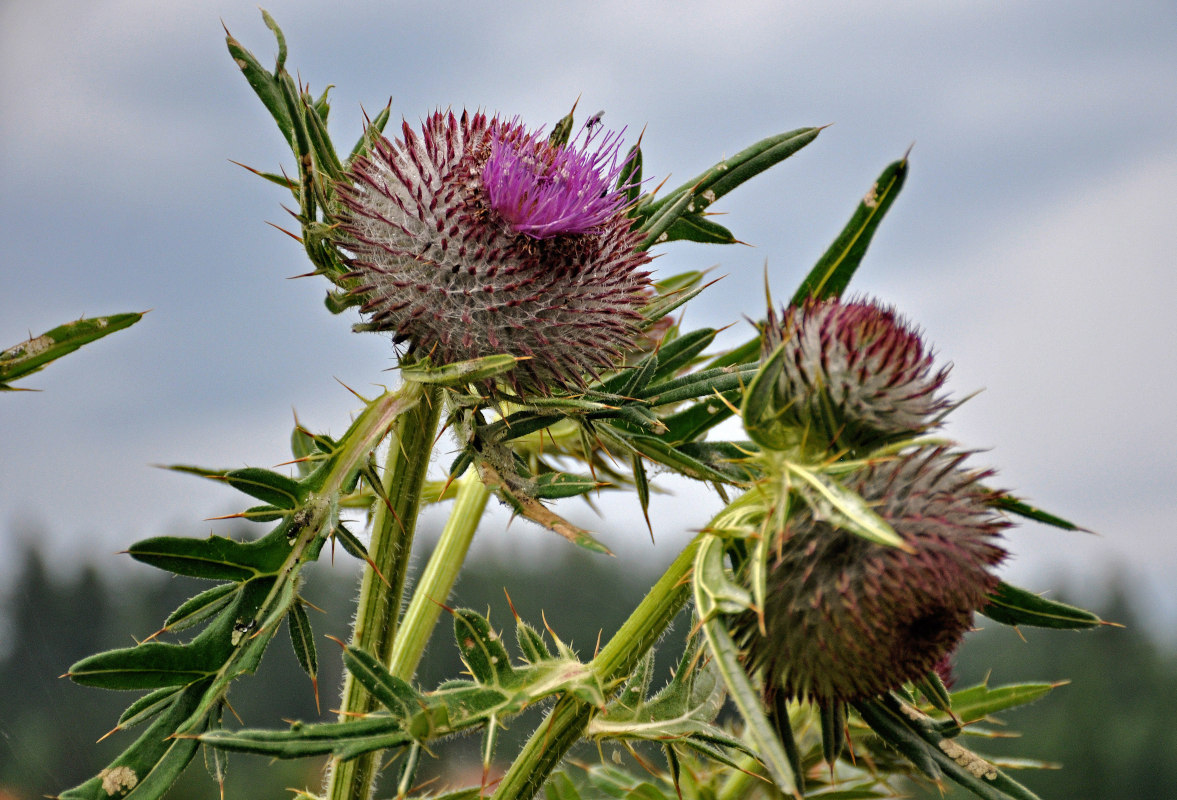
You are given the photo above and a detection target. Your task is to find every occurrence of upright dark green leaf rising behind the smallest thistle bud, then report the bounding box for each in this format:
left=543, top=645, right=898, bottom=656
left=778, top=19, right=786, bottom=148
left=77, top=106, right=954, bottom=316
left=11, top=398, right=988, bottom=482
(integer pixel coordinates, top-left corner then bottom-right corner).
left=790, top=156, right=907, bottom=306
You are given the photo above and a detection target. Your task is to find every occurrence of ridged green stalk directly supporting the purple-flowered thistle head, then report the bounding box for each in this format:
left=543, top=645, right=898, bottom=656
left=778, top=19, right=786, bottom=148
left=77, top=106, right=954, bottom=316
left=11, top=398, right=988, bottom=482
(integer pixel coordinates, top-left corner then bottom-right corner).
left=327, top=384, right=441, bottom=800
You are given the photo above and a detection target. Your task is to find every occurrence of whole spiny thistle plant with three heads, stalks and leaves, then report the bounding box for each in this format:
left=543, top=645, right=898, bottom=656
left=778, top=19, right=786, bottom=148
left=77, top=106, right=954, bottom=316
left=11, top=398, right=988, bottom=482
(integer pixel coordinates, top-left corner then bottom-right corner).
left=48, top=13, right=1100, bottom=800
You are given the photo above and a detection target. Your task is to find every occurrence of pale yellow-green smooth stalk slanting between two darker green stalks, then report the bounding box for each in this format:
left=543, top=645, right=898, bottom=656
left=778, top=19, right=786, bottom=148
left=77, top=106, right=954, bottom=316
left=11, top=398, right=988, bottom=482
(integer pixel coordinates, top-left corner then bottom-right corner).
left=388, top=468, right=491, bottom=681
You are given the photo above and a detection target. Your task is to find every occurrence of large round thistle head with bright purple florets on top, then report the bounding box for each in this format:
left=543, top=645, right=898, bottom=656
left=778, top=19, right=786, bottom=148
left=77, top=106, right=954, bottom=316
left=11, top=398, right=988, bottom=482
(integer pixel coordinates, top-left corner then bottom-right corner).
left=338, top=112, right=650, bottom=394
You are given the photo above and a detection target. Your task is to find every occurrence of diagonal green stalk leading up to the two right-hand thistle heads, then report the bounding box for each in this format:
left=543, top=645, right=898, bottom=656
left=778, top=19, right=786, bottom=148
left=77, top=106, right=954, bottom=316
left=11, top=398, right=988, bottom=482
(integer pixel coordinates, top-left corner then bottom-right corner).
left=494, top=529, right=707, bottom=800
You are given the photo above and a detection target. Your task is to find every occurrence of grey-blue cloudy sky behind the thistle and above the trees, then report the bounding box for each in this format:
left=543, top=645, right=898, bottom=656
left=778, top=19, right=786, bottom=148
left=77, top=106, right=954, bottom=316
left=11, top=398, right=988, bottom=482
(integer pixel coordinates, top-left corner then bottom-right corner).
left=0, top=0, right=1177, bottom=630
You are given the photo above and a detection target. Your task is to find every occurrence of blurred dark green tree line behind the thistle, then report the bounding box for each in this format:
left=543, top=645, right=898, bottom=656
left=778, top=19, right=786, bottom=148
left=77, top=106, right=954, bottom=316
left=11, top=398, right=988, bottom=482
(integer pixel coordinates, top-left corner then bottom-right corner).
left=0, top=527, right=1177, bottom=800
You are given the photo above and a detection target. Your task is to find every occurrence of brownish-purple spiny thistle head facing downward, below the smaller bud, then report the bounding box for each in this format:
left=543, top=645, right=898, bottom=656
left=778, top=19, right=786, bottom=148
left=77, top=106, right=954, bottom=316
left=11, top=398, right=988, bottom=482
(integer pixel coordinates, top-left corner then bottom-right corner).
left=733, top=447, right=1008, bottom=705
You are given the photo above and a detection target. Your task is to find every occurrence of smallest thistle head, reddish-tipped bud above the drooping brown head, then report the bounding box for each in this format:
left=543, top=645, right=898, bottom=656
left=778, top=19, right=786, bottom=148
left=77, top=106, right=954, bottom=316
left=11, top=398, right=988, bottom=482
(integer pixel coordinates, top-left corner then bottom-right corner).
left=762, top=299, right=950, bottom=452
